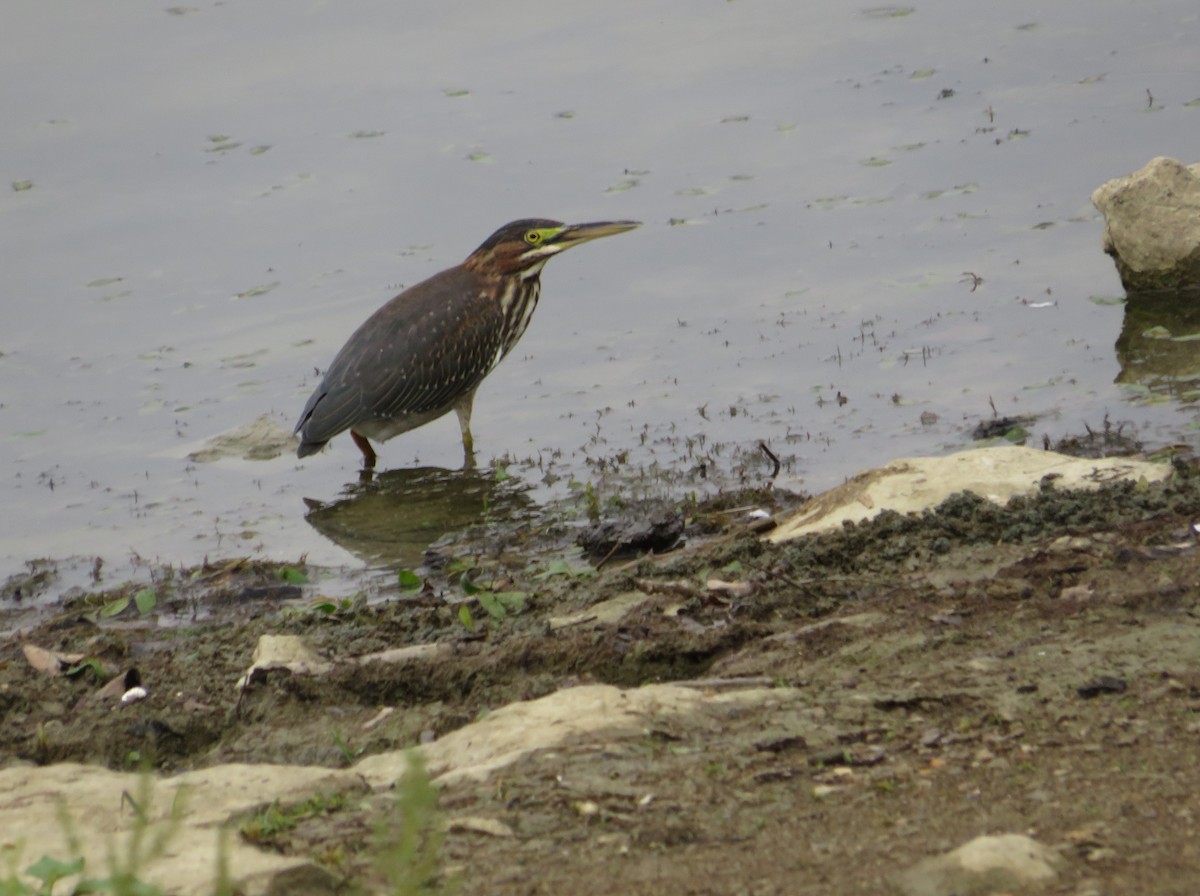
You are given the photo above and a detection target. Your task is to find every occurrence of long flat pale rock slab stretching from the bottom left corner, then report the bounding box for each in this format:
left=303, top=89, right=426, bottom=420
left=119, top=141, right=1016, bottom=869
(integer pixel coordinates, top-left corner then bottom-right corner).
left=0, top=681, right=800, bottom=896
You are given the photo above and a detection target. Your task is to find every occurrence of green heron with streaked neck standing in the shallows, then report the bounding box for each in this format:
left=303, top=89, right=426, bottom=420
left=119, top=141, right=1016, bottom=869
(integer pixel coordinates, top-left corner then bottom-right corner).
left=295, top=218, right=638, bottom=470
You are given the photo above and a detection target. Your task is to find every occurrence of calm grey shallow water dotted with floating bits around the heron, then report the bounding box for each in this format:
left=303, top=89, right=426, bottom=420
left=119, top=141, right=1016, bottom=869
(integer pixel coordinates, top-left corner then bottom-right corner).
left=0, top=0, right=1200, bottom=578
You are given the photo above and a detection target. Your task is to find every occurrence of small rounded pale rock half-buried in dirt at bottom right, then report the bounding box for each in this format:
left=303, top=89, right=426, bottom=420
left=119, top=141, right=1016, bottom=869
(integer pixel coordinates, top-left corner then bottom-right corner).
left=893, top=834, right=1063, bottom=896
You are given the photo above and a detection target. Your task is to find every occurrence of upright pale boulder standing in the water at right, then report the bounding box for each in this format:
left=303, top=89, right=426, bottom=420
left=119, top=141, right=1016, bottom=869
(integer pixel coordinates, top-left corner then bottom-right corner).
left=1092, top=156, right=1200, bottom=293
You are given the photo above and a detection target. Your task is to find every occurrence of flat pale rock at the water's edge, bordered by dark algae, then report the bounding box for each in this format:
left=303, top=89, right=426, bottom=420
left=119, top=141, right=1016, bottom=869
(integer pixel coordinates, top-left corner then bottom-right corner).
left=768, top=445, right=1171, bottom=542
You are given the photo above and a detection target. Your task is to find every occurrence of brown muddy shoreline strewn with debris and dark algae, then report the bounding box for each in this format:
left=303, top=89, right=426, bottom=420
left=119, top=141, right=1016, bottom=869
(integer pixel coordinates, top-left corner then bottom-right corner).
left=0, top=464, right=1200, bottom=894
